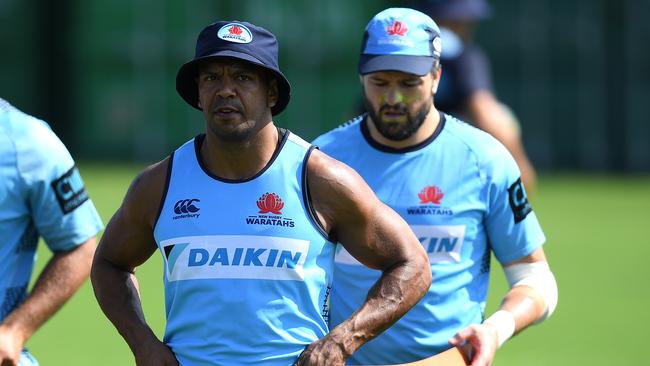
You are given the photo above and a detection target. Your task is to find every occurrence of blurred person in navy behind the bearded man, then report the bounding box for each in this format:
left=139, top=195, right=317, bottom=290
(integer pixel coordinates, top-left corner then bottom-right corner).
left=417, top=0, right=536, bottom=197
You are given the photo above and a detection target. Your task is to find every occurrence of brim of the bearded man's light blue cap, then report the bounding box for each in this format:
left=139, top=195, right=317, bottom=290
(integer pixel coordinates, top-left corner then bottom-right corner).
left=359, top=54, right=436, bottom=76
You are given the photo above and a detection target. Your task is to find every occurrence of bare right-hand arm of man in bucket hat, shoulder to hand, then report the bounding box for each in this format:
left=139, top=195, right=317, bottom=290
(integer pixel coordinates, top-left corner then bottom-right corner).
left=298, top=151, right=431, bottom=365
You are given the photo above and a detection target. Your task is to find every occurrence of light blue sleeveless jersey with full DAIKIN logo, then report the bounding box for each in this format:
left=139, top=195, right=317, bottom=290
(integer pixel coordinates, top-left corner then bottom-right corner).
left=154, top=131, right=335, bottom=365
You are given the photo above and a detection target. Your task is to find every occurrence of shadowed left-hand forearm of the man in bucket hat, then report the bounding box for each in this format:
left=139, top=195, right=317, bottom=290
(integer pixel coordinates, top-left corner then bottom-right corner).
left=91, top=257, right=158, bottom=354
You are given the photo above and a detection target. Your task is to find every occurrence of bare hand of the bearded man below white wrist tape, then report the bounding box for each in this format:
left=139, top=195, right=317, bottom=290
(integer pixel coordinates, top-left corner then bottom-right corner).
left=449, top=324, right=498, bottom=366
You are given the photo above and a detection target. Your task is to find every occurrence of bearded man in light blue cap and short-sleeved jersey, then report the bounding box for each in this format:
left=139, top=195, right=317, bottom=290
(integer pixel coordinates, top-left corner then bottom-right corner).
left=314, top=8, right=557, bottom=365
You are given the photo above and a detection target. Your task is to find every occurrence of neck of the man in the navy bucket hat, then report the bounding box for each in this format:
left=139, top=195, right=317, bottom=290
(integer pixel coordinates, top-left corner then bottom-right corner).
left=201, top=122, right=279, bottom=180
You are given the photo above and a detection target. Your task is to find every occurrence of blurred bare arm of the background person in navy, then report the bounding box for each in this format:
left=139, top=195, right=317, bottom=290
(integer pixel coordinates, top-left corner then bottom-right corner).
left=467, top=90, right=537, bottom=196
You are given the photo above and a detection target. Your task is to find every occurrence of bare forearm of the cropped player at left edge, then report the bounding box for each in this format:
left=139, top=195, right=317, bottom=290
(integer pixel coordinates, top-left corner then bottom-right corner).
left=0, top=237, right=95, bottom=365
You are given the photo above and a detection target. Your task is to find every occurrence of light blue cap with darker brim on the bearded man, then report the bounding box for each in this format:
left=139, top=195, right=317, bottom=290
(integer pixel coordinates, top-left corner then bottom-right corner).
left=359, top=8, right=442, bottom=76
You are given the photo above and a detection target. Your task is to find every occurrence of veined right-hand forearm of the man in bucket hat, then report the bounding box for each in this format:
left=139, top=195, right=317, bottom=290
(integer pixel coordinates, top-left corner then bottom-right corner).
left=332, top=258, right=431, bottom=354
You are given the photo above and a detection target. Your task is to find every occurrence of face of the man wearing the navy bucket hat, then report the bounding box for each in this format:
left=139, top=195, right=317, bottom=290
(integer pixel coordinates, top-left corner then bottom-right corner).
left=197, top=58, right=278, bottom=142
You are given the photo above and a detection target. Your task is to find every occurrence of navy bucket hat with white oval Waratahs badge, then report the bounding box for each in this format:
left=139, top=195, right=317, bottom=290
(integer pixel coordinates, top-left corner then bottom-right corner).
left=176, top=21, right=291, bottom=116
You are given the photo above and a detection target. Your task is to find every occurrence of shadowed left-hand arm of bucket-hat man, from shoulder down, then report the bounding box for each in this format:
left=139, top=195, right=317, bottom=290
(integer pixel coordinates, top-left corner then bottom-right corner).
left=91, top=160, right=177, bottom=365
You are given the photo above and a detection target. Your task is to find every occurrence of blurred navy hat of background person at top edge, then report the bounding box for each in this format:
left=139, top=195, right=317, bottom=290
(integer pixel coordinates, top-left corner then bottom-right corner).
left=422, top=0, right=492, bottom=20
